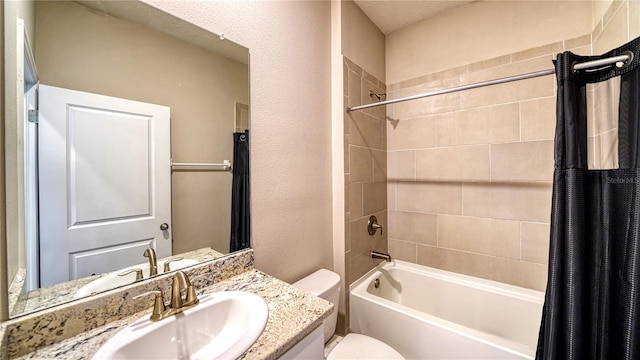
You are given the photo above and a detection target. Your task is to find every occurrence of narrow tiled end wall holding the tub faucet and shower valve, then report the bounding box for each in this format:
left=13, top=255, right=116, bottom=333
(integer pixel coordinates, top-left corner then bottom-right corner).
left=342, top=57, right=388, bottom=313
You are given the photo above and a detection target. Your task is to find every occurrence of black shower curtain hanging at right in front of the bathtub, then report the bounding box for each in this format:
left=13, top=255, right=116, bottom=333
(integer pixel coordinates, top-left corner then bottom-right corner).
left=536, top=38, right=640, bottom=360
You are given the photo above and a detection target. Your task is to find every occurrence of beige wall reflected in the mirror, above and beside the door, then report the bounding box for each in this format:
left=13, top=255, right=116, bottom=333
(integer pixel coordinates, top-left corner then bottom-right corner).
left=35, top=2, right=249, bottom=254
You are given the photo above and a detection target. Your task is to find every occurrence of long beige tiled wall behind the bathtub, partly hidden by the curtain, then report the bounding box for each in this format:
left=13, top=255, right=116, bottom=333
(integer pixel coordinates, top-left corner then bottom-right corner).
left=387, top=1, right=640, bottom=290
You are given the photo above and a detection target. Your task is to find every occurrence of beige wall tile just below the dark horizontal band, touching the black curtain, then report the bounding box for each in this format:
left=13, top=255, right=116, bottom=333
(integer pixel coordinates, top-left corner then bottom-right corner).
left=462, top=183, right=552, bottom=222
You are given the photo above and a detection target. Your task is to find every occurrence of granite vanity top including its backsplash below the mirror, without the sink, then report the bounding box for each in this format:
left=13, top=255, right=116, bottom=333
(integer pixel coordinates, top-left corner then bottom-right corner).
left=0, top=250, right=334, bottom=359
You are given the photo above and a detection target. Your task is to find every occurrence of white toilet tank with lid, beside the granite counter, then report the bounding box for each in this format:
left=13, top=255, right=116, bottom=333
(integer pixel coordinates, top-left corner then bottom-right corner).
left=293, top=269, right=340, bottom=343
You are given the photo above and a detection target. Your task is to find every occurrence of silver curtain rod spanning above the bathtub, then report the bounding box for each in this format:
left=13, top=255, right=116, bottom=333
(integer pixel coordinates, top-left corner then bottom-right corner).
left=347, top=52, right=633, bottom=112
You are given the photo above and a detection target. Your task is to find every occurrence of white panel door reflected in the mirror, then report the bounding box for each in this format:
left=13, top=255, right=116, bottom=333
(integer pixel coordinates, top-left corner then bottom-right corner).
left=39, top=85, right=171, bottom=287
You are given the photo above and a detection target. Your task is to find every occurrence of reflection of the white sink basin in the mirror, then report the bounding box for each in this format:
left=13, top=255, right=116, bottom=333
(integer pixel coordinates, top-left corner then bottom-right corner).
left=73, top=259, right=199, bottom=299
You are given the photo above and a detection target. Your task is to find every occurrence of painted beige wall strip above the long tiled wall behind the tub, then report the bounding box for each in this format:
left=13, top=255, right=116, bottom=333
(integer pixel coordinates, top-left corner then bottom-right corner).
left=386, top=1, right=592, bottom=84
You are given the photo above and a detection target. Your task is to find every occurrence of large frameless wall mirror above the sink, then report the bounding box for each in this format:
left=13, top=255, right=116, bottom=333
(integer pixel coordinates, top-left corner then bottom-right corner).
left=3, top=0, right=250, bottom=318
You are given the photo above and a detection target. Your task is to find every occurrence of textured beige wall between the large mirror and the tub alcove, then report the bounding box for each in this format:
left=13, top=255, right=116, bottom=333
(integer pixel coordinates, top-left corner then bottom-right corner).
left=145, top=1, right=333, bottom=281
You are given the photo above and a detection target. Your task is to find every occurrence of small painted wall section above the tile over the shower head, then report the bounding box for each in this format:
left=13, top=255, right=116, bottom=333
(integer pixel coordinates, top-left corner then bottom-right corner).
left=341, top=0, right=385, bottom=79
